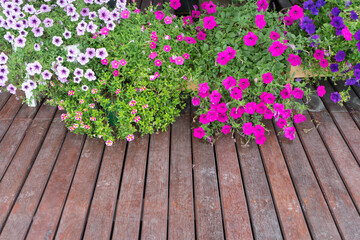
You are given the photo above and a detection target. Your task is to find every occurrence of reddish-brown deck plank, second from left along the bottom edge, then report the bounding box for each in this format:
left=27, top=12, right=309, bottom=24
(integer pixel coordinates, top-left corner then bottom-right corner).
left=26, top=133, right=84, bottom=240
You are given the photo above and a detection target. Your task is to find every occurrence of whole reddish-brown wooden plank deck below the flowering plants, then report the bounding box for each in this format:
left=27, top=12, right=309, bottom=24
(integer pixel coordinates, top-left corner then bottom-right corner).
left=0, top=80, right=360, bottom=240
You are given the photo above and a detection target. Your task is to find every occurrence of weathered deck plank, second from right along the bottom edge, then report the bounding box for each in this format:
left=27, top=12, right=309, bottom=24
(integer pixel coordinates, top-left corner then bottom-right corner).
left=270, top=120, right=341, bottom=240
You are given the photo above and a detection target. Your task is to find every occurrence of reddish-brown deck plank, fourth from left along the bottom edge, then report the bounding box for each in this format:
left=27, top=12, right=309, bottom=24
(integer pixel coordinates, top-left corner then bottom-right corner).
left=84, top=141, right=126, bottom=240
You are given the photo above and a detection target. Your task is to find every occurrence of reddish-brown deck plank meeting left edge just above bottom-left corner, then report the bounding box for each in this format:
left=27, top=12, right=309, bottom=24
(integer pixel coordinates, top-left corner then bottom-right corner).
left=0, top=114, right=51, bottom=228
